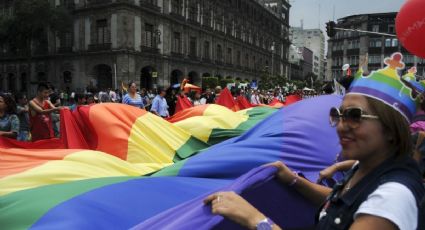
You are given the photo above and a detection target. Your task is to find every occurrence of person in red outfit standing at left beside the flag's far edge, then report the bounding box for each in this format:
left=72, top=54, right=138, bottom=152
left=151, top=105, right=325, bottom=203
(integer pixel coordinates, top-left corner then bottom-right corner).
left=29, top=83, right=61, bottom=141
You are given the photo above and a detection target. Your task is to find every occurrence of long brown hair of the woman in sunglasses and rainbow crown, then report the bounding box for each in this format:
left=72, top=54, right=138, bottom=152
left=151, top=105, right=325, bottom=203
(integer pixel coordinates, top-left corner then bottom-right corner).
left=366, top=97, right=413, bottom=156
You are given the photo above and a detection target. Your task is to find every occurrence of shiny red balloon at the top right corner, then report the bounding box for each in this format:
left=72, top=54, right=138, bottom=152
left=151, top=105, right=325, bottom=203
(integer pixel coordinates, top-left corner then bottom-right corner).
left=396, top=0, right=425, bottom=58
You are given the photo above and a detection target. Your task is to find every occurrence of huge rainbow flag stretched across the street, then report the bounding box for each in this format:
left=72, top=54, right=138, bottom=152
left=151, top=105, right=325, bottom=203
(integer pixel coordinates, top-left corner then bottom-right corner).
left=0, top=96, right=341, bottom=229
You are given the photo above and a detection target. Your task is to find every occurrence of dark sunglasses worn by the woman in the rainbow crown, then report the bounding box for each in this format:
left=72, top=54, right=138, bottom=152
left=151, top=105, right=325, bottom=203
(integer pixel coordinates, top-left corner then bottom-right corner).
left=329, top=107, right=379, bottom=129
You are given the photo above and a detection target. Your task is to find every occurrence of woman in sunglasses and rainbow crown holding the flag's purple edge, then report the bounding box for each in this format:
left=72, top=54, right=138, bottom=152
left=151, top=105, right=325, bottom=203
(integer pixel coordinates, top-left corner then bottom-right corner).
left=205, top=53, right=425, bottom=230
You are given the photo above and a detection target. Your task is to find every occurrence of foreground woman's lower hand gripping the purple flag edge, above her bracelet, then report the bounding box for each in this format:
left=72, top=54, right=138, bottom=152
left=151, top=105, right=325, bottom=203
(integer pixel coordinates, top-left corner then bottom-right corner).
left=204, top=192, right=266, bottom=229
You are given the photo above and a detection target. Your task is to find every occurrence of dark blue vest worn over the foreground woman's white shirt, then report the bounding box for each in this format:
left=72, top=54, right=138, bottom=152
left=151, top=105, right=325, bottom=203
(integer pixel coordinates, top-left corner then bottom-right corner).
left=316, top=157, right=425, bottom=230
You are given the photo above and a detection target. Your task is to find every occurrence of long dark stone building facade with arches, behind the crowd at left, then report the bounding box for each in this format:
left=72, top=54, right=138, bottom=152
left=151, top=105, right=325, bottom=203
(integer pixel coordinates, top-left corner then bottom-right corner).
left=0, top=0, right=290, bottom=94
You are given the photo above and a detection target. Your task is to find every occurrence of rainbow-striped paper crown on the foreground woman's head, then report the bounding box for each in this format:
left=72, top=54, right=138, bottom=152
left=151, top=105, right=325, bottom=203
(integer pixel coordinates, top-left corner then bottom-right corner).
left=347, top=53, right=422, bottom=123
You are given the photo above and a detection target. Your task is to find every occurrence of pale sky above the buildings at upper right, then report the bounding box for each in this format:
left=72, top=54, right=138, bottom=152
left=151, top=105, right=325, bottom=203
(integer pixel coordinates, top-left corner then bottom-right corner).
left=289, top=0, right=406, bottom=30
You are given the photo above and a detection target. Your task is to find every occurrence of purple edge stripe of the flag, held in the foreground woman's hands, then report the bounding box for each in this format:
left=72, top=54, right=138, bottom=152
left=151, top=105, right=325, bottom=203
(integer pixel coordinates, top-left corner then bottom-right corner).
left=132, top=166, right=316, bottom=230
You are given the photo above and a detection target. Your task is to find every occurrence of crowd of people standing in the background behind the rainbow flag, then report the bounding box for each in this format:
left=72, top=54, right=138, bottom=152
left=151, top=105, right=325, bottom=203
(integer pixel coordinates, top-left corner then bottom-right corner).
left=0, top=81, right=317, bottom=141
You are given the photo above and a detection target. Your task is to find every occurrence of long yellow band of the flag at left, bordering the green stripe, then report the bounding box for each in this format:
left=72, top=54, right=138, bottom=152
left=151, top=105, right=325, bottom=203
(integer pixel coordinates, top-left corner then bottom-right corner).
left=0, top=150, right=169, bottom=196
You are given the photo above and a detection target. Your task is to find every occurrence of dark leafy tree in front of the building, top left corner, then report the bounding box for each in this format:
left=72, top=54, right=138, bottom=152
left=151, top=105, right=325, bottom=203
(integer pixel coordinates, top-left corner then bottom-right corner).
left=0, top=0, right=72, bottom=88
